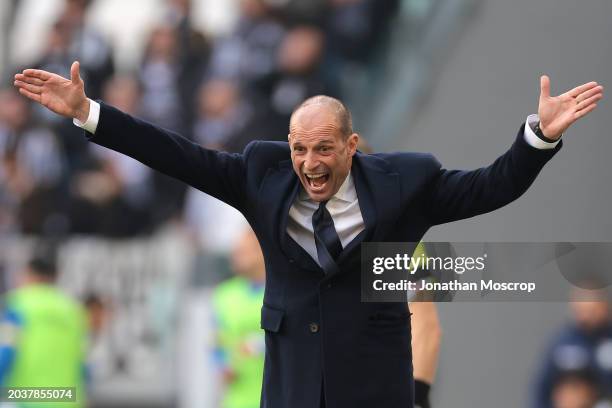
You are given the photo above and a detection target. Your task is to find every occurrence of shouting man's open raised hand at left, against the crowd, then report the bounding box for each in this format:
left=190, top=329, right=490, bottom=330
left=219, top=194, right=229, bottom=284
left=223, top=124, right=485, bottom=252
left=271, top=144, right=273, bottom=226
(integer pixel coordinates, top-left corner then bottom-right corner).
left=14, top=61, right=89, bottom=122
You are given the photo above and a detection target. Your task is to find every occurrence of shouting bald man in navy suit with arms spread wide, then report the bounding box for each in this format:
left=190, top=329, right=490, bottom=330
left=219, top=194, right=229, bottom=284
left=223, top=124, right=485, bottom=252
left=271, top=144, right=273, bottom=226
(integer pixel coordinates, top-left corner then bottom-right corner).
left=15, top=63, right=603, bottom=408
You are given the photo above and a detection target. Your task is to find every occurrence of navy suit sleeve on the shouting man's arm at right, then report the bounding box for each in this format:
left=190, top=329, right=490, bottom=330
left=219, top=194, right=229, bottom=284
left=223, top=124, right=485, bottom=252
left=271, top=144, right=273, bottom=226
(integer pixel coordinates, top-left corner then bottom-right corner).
left=425, top=125, right=563, bottom=225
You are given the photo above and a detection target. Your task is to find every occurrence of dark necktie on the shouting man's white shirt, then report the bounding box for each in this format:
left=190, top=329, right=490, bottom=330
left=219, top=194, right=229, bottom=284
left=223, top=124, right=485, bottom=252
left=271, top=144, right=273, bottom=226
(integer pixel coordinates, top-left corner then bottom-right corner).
left=312, top=201, right=342, bottom=273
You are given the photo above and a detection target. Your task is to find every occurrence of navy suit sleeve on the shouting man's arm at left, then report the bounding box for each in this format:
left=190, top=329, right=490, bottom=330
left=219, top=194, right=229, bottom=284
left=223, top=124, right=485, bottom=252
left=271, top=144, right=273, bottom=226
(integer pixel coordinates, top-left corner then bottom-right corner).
left=86, top=102, right=256, bottom=211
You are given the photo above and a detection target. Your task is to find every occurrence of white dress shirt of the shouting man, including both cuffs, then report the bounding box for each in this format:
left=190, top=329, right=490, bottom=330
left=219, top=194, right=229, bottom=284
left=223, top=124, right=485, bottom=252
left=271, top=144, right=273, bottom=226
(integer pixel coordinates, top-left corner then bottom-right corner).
left=74, top=99, right=560, bottom=264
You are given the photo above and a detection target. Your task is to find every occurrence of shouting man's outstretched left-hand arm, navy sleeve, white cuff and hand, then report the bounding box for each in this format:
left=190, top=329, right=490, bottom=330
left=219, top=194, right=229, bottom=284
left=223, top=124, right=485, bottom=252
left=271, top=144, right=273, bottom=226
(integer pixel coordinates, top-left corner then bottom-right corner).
left=15, top=62, right=253, bottom=211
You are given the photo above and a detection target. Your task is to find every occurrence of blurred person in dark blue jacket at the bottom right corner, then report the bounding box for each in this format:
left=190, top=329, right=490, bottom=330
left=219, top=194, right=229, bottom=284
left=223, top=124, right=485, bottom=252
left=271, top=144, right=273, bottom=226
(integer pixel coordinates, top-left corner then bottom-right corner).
left=533, top=288, right=612, bottom=408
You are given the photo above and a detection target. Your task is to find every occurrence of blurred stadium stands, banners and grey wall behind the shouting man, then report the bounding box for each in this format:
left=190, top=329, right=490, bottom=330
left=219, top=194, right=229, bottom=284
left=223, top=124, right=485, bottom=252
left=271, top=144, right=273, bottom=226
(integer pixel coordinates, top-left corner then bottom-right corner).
left=0, top=0, right=612, bottom=407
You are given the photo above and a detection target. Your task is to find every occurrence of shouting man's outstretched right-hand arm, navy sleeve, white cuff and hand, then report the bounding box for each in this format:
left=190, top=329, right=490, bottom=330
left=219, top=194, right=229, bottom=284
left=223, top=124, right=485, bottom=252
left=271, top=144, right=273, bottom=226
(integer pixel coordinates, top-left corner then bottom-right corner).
left=426, top=75, right=603, bottom=225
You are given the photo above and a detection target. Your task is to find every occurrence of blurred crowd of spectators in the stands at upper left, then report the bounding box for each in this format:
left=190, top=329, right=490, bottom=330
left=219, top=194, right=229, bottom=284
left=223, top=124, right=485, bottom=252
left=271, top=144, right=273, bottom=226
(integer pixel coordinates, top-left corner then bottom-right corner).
left=0, top=0, right=400, bottom=238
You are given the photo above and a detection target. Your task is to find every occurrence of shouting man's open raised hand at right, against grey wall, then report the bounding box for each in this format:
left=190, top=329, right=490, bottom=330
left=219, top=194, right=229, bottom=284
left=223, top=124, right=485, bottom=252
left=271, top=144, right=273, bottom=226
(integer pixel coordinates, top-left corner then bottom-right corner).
left=538, top=75, right=603, bottom=140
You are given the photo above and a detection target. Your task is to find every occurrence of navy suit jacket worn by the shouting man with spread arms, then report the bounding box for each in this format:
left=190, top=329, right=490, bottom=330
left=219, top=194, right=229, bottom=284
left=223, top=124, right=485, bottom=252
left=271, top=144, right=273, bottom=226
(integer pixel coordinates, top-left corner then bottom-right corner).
left=88, top=104, right=561, bottom=408
